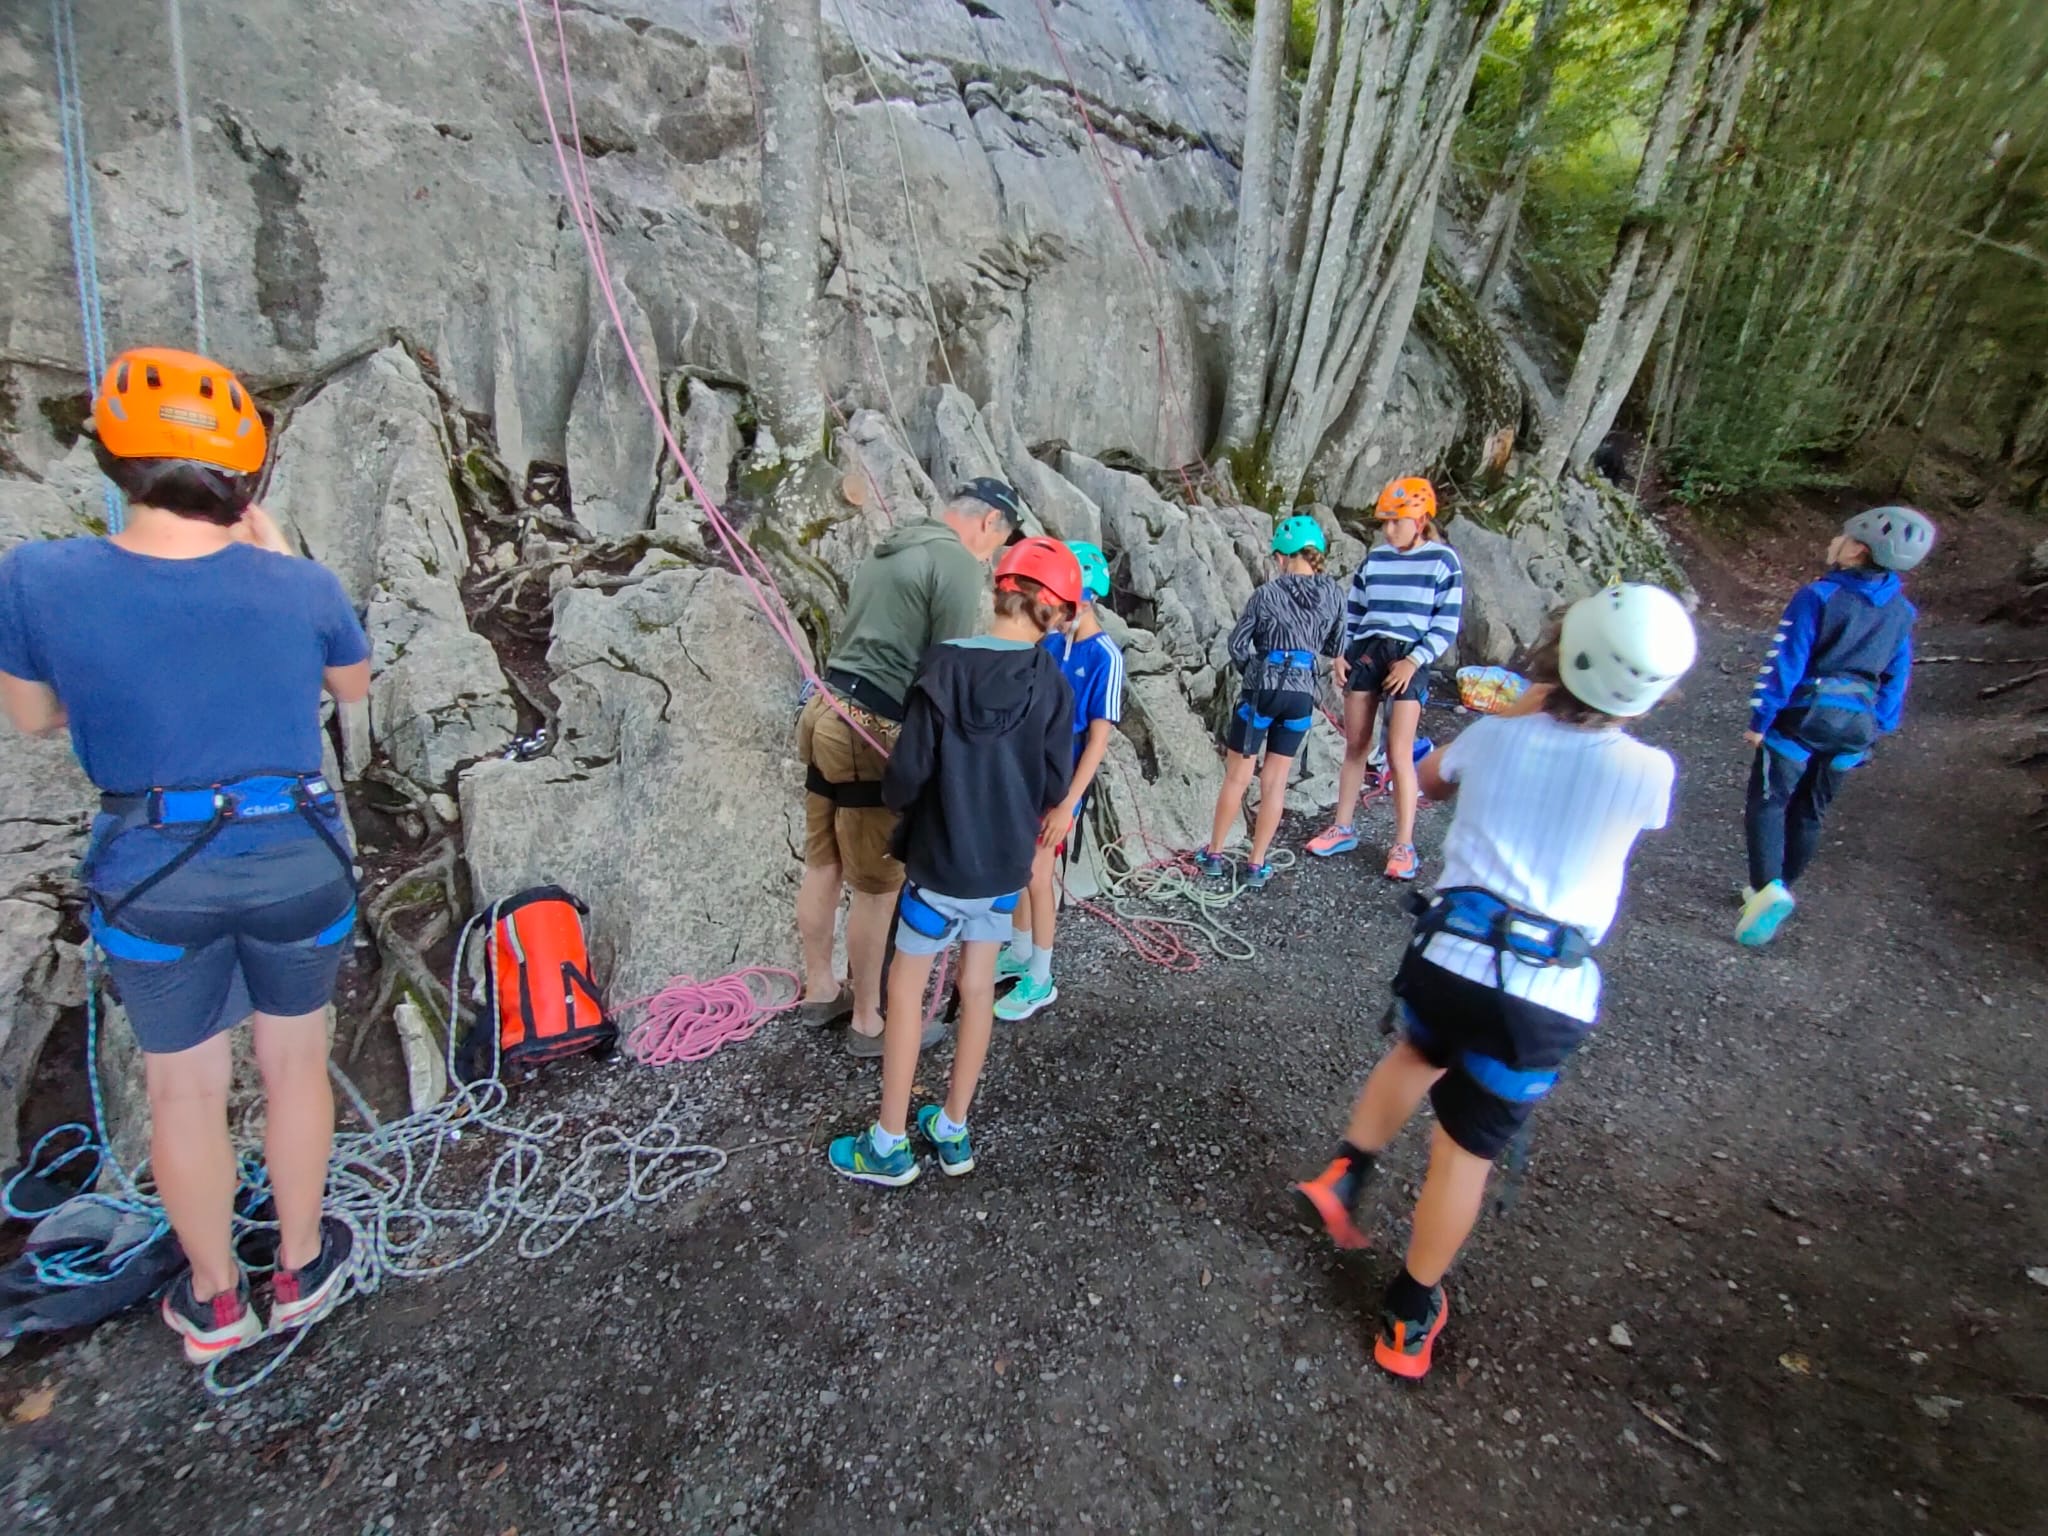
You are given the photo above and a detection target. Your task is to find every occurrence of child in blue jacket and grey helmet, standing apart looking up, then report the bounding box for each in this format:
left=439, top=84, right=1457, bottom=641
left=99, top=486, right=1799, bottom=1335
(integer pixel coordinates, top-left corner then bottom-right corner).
left=1735, top=506, right=1933, bottom=948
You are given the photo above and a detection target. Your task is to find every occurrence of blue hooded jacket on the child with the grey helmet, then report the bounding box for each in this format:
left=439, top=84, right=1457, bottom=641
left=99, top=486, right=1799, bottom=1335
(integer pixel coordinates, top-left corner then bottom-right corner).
left=1749, top=569, right=1919, bottom=733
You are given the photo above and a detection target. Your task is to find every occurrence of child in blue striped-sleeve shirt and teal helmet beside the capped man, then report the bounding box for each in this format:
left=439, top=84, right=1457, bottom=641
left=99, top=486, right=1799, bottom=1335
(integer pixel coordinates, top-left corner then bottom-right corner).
left=995, top=541, right=1124, bottom=1022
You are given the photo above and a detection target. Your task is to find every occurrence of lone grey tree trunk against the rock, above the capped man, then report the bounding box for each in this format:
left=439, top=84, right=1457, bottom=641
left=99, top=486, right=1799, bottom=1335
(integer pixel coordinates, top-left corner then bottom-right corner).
left=754, top=0, right=825, bottom=457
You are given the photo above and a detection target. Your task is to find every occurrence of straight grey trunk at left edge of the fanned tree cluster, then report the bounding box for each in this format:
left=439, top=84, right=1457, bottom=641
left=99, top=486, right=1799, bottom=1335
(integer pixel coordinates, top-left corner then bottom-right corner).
left=1221, top=0, right=1298, bottom=449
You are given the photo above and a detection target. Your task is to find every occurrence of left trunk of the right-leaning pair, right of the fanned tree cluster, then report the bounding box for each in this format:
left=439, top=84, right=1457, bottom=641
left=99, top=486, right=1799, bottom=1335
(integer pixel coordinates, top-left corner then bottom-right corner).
left=1536, top=0, right=1753, bottom=481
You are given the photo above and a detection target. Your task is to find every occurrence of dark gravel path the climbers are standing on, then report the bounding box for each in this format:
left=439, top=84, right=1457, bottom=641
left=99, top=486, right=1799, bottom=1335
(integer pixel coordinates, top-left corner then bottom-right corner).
left=0, top=618, right=2048, bottom=1536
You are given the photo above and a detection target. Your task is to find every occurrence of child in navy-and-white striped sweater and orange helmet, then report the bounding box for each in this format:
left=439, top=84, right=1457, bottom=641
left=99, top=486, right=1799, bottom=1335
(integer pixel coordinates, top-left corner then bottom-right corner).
left=1309, top=479, right=1464, bottom=881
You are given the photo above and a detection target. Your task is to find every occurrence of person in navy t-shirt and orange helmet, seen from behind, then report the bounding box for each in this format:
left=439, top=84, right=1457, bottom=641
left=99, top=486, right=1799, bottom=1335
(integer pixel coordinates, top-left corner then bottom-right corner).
left=0, top=348, right=371, bottom=1364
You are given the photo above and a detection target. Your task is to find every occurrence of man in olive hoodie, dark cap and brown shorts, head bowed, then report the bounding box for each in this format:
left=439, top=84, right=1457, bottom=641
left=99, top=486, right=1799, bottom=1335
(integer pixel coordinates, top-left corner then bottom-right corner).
left=797, top=479, right=1024, bottom=1057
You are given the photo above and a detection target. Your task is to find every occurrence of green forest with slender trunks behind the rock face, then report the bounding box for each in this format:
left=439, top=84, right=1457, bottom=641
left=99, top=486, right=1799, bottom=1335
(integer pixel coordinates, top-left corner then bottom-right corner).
left=1223, top=0, right=2048, bottom=518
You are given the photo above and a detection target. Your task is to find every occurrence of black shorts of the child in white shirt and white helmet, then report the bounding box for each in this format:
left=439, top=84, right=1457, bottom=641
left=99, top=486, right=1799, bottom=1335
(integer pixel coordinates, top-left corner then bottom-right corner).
left=1395, top=950, right=1593, bottom=1161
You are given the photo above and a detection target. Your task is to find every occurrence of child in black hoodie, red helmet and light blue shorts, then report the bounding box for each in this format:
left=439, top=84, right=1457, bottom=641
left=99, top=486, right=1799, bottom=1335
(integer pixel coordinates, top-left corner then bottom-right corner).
left=825, top=539, right=1081, bottom=1188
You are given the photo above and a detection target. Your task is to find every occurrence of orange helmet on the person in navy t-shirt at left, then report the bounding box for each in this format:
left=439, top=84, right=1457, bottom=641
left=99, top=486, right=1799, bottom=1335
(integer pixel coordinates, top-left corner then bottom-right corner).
left=92, top=346, right=270, bottom=475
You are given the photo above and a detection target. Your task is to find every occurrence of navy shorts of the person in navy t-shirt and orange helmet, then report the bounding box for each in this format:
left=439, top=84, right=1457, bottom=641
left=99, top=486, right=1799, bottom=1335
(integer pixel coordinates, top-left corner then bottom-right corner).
left=92, top=829, right=356, bottom=1055
